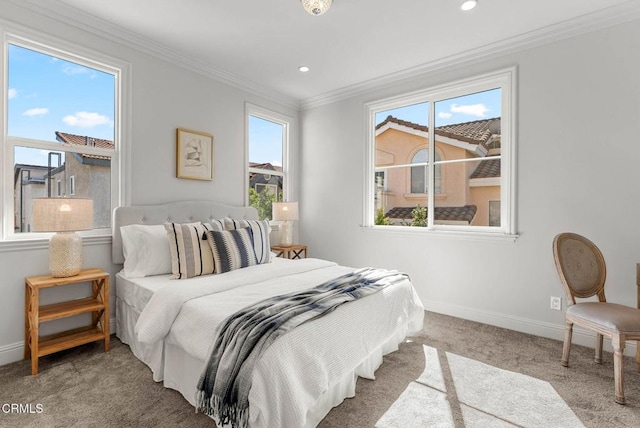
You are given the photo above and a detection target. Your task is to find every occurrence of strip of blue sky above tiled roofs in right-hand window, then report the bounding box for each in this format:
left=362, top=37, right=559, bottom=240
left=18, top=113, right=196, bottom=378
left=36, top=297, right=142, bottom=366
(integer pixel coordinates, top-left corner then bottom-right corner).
left=376, top=89, right=501, bottom=126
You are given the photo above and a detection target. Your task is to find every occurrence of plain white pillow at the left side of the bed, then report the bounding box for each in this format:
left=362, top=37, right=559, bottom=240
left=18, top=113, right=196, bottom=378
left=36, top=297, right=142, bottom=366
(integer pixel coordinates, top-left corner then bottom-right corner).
left=120, top=224, right=171, bottom=278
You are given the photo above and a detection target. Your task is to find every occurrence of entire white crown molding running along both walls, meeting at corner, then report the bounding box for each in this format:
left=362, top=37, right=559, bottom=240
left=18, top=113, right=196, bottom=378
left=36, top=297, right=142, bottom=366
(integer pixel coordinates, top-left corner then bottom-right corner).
left=7, top=0, right=640, bottom=110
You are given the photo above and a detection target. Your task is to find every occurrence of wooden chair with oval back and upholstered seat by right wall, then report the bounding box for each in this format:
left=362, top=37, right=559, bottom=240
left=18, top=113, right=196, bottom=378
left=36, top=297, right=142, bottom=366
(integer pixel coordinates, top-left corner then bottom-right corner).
left=553, top=233, right=640, bottom=404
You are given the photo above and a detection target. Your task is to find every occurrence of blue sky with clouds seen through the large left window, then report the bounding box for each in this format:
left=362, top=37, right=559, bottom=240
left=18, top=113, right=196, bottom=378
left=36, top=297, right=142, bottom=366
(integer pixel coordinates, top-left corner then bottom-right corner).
left=8, top=45, right=115, bottom=165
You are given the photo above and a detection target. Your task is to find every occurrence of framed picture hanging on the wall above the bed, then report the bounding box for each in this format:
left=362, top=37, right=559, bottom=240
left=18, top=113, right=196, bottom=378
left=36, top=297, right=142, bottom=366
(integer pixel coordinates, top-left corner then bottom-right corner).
left=176, top=128, right=213, bottom=180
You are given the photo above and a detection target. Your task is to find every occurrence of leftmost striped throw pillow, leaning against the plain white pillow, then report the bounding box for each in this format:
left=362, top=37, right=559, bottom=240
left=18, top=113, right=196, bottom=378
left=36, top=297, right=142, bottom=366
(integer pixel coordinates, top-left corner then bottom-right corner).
left=164, top=223, right=213, bottom=279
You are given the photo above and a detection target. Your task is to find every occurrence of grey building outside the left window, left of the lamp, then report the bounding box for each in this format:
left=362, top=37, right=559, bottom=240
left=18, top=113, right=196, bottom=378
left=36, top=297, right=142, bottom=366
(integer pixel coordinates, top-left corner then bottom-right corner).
left=13, top=164, right=48, bottom=232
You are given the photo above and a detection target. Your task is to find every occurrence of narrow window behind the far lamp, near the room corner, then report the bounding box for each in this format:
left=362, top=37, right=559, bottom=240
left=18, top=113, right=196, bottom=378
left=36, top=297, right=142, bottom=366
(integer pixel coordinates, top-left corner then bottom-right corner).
left=247, top=104, right=291, bottom=219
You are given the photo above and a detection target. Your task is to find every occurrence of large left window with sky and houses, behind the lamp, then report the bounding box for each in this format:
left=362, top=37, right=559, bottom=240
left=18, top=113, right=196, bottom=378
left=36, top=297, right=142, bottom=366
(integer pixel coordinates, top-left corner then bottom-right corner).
left=2, top=34, right=127, bottom=239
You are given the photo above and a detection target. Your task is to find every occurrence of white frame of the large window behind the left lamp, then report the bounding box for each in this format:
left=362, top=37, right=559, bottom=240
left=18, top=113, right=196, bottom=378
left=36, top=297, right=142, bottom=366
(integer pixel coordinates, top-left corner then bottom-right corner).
left=0, top=28, right=131, bottom=246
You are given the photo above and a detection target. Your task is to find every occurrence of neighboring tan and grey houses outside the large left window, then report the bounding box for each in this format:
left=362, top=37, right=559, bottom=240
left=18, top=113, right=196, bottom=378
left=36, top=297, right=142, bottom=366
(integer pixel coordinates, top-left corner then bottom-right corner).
left=14, top=132, right=114, bottom=232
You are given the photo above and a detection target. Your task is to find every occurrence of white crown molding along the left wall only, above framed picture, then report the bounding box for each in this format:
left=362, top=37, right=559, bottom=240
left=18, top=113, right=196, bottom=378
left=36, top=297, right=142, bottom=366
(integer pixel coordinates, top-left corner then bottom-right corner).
left=8, top=0, right=299, bottom=109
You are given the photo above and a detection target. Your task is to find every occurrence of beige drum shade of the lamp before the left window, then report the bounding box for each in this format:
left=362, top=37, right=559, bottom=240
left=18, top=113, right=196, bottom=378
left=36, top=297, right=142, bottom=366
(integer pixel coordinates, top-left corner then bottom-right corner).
left=32, top=198, right=93, bottom=232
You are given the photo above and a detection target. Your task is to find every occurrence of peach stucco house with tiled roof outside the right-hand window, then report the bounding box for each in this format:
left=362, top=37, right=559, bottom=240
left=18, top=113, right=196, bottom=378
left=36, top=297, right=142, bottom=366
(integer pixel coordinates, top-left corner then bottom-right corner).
left=376, top=116, right=500, bottom=226
